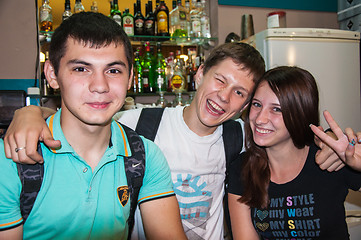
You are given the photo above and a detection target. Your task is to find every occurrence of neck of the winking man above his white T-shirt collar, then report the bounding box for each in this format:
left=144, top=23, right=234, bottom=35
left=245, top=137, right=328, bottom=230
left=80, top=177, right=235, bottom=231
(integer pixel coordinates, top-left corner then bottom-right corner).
left=183, top=101, right=218, bottom=137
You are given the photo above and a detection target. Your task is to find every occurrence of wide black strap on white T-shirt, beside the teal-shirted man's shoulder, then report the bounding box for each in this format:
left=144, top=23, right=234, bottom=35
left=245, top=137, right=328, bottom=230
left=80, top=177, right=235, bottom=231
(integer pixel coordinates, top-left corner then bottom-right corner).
left=135, top=108, right=164, bottom=141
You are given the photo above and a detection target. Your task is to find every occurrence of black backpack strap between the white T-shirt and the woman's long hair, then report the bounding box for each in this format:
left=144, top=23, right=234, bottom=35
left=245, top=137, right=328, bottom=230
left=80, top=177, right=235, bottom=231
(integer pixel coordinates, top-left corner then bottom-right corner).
left=222, top=120, right=243, bottom=239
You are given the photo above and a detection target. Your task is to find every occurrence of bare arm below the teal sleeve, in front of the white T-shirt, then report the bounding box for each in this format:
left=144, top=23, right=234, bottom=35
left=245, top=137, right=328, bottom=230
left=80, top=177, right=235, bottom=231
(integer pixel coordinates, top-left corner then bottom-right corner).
left=140, top=196, right=187, bottom=240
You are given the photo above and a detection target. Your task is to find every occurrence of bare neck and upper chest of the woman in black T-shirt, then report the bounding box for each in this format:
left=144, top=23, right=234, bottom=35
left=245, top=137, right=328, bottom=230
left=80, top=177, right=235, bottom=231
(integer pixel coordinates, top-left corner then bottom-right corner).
left=266, top=141, right=309, bottom=184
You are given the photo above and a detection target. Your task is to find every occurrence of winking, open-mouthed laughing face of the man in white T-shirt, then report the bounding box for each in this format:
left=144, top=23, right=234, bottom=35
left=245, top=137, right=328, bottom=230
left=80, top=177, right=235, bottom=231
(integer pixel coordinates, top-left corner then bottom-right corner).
left=185, top=58, right=254, bottom=135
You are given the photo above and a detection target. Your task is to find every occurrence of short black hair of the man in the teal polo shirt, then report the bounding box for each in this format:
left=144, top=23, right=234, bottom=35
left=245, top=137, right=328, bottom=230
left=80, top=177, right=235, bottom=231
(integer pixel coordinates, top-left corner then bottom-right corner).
left=49, top=12, right=133, bottom=76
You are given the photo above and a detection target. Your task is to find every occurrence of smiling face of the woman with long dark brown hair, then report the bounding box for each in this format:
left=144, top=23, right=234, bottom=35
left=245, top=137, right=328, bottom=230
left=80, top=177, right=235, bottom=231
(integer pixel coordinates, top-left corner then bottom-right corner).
left=249, top=81, right=293, bottom=147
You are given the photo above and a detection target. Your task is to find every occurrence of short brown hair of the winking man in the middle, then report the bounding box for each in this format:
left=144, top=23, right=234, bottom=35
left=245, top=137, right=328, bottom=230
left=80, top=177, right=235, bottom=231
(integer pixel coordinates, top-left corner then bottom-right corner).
left=203, top=42, right=265, bottom=83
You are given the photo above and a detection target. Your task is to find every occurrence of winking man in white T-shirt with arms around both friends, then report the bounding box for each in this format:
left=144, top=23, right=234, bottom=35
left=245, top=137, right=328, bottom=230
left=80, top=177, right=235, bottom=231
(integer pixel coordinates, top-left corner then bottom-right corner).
left=6, top=43, right=340, bottom=240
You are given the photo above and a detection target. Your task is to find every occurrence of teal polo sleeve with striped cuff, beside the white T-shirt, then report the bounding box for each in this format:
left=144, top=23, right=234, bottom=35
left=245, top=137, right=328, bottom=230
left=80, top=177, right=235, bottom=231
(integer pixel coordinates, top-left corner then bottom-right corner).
left=138, top=137, right=174, bottom=203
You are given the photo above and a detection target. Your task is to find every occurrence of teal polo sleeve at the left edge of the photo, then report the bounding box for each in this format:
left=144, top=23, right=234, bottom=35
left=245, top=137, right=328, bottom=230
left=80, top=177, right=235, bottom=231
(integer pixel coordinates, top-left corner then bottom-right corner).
left=0, top=139, right=23, bottom=231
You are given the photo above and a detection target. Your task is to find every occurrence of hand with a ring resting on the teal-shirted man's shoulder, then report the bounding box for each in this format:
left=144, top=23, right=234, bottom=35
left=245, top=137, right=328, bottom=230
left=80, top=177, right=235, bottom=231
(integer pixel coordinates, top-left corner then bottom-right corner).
left=4, top=106, right=60, bottom=163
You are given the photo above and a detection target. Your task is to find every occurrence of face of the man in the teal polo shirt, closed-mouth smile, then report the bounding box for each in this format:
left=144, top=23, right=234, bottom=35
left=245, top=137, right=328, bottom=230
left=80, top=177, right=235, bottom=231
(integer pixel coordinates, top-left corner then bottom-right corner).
left=44, top=38, right=132, bottom=129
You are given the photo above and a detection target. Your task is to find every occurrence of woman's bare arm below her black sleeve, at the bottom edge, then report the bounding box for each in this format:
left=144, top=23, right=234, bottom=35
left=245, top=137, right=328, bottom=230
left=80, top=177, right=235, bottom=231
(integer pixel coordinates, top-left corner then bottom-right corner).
left=228, top=193, right=259, bottom=240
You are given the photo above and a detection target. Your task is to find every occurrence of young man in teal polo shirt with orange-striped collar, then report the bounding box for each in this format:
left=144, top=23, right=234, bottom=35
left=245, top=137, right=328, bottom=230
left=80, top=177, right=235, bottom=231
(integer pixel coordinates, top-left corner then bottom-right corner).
left=0, top=13, right=185, bottom=239
